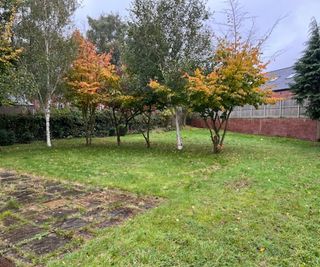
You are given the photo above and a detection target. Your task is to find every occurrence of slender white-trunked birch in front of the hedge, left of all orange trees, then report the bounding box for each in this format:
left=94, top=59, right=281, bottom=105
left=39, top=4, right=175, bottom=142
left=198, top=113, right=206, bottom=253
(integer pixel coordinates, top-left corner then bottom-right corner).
left=16, top=0, right=78, bottom=147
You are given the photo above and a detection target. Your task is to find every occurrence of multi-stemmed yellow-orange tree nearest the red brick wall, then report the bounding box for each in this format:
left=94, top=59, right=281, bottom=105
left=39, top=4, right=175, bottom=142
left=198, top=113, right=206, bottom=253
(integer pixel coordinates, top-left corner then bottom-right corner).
left=187, top=40, right=275, bottom=153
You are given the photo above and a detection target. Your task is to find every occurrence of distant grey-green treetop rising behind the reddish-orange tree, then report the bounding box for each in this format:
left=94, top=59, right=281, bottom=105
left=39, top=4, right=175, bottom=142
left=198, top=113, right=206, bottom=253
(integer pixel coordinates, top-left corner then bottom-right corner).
left=87, top=14, right=127, bottom=66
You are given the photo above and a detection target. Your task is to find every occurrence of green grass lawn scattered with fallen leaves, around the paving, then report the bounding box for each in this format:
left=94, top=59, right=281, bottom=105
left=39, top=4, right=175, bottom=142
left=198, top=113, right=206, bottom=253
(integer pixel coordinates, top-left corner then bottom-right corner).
left=0, top=129, right=320, bottom=267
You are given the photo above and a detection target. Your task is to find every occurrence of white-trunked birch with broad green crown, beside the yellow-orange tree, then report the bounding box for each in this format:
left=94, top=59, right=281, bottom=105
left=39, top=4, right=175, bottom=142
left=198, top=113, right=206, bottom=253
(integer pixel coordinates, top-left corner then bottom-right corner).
left=126, top=0, right=211, bottom=149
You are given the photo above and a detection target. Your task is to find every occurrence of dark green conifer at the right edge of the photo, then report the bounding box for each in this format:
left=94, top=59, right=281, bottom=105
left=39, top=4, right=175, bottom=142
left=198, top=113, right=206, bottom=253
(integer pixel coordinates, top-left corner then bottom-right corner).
left=291, top=19, right=320, bottom=120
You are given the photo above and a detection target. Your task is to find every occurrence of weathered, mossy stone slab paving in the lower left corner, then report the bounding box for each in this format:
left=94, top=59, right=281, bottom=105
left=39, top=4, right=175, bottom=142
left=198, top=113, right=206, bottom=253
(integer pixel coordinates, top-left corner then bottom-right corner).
left=0, top=170, right=160, bottom=267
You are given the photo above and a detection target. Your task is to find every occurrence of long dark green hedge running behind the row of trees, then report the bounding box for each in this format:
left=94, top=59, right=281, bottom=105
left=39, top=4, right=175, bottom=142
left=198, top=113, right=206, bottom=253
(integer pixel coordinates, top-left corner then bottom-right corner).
left=0, top=110, right=172, bottom=147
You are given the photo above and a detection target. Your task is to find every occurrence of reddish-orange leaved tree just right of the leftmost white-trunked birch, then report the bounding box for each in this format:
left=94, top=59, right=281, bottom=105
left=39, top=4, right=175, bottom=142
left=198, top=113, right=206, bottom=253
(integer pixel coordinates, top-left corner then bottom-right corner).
left=66, top=31, right=115, bottom=145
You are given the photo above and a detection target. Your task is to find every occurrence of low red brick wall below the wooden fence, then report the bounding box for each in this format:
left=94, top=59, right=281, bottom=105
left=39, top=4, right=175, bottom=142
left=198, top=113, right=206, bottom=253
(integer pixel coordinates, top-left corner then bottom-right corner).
left=191, top=118, right=320, bottom=141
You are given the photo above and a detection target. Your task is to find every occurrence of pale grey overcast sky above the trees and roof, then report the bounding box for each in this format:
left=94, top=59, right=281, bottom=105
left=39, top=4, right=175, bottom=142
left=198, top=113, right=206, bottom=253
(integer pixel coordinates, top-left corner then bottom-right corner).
left=76, top=0, right=320, bottom=70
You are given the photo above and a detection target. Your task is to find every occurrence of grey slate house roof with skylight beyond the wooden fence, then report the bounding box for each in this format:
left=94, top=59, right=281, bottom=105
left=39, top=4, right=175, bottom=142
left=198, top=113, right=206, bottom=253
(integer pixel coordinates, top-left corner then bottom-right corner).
left=267, top=67, right=295, bottom=92
